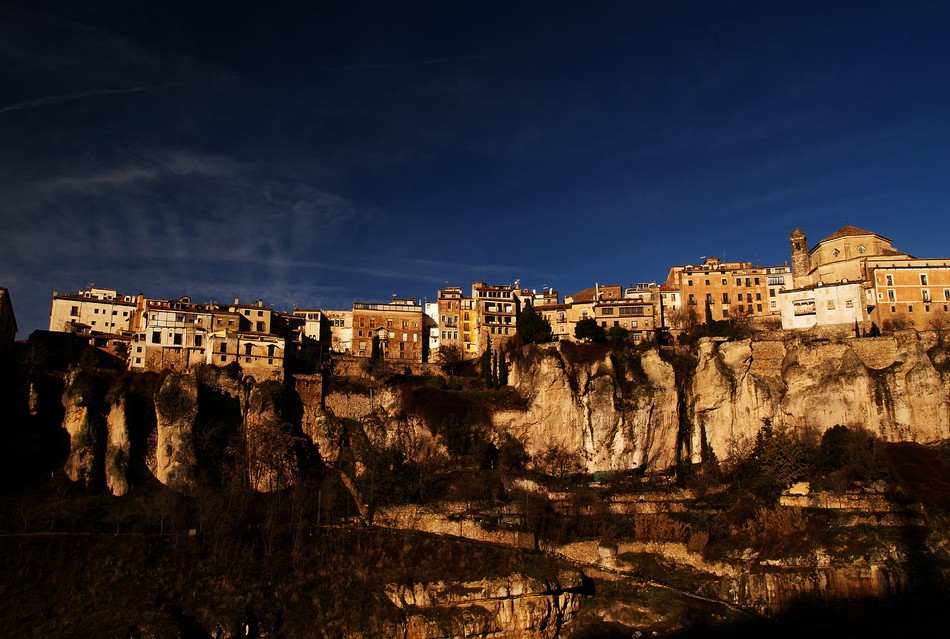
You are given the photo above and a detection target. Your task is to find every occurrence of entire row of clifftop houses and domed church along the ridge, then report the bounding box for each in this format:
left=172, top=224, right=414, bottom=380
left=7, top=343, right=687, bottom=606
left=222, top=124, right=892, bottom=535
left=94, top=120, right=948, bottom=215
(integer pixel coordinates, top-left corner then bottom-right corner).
left=29, top=226, right=950, bottom=375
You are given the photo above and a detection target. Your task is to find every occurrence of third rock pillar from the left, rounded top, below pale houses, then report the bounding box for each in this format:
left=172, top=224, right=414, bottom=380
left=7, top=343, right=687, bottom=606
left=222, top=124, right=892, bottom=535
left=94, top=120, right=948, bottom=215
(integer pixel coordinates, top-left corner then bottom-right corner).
left=149, top=373, right=198, bottom=492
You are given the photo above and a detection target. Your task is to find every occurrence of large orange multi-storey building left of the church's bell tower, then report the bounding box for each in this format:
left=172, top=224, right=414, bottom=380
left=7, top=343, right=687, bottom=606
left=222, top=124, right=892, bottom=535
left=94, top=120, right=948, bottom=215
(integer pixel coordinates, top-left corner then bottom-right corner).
left=665, top=257, right=777, bottom=323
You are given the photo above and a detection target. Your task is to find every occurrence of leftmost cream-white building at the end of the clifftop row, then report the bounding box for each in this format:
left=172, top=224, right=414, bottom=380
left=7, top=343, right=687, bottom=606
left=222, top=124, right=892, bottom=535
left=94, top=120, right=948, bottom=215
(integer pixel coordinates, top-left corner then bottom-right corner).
left=49, top=288, right=141, bottom=334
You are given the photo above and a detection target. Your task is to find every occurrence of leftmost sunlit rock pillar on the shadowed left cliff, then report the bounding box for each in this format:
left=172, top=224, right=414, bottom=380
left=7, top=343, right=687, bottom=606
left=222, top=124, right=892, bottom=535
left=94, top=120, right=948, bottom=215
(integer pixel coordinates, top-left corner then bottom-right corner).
left=63, top=371, right=105, bottom=488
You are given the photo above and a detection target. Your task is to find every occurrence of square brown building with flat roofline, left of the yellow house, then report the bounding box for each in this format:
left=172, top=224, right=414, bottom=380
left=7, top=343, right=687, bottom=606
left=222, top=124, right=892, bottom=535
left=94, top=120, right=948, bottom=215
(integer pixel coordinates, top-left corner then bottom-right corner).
left=352, top=297, right=427, bottom=362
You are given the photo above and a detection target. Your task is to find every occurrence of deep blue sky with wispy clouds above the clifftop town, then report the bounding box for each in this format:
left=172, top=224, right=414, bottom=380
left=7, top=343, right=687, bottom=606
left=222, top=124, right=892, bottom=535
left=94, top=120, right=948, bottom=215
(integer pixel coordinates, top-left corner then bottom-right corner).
left=0, top=0, right=950, bottom=338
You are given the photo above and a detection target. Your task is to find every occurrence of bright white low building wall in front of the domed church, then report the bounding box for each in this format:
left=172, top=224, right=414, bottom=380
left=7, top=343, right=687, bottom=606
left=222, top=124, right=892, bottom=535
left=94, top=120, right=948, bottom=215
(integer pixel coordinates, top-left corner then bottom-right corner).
left=778, top=282, right=867, bottom=329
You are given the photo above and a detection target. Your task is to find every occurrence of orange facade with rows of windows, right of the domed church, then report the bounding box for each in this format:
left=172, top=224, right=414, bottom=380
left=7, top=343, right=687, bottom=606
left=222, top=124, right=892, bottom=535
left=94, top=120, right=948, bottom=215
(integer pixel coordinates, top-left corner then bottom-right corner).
left=867, top=258, right=950, bottom=331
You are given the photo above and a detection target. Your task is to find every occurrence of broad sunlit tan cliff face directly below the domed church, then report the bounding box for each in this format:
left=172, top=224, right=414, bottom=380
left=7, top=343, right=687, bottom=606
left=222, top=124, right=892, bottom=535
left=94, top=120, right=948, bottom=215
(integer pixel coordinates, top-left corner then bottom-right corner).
left=688, top=331, right=950, bottom=461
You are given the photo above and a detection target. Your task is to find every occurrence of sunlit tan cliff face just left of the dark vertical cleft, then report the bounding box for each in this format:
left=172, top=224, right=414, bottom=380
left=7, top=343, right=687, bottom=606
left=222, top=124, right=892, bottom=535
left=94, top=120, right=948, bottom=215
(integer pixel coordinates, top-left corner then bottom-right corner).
left=502, top=343, right=679, bottom=472
